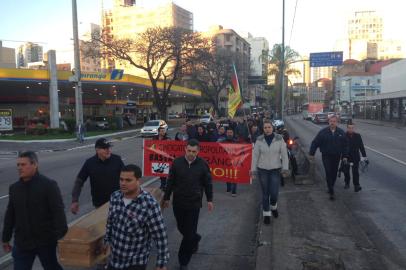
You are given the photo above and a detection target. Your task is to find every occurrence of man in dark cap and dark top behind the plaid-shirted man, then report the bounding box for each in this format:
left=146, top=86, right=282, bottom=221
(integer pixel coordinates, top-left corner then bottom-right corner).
left=71, top=138, right=124, bottom=214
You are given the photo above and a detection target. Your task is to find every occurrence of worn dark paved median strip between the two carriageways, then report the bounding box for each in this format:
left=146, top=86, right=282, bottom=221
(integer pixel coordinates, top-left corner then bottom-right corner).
left=256, top=117, right=398, bottom=270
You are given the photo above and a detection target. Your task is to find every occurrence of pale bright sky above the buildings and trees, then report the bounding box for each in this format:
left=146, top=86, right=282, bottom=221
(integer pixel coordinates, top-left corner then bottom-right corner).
left=0, top=0, right=406, bottom=62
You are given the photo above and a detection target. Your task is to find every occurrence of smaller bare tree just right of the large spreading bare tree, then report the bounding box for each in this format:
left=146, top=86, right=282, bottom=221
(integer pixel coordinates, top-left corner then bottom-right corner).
left=190, top=47, right=236, bottom=114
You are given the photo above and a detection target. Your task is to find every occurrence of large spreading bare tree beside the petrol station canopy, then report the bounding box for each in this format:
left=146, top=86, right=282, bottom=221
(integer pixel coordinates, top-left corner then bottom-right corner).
left=84, top=27, right=207, bottom=119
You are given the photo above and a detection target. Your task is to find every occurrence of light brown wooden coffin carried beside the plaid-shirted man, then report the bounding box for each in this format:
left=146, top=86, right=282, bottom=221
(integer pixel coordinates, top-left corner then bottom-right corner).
left=58, top=188, right=162, bottom=267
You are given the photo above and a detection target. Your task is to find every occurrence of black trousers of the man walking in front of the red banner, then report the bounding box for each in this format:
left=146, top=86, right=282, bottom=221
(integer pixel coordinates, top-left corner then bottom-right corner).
left=173, top=205, right=200, bottom=265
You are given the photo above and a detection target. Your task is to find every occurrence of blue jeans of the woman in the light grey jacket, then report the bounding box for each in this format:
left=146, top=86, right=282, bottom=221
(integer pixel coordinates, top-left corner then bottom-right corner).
left=258, top=168, right=281, bottom=212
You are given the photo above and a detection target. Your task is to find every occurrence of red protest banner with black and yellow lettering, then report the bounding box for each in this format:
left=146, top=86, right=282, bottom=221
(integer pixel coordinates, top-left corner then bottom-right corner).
left=143, top=140, right=252, bottom=184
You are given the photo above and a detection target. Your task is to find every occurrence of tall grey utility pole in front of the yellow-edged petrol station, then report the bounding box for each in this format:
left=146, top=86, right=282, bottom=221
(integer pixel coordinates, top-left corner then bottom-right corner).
left=72, top=0, right=83, bottom=126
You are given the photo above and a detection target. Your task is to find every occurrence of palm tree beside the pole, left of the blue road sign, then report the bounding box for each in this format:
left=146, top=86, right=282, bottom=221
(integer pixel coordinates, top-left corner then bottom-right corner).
left=268, top=44, right=300, bottom=115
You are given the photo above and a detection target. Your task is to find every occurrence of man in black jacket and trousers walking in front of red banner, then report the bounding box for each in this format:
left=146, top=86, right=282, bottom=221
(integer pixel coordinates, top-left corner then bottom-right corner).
left=161, top=139, right=214, bottom=269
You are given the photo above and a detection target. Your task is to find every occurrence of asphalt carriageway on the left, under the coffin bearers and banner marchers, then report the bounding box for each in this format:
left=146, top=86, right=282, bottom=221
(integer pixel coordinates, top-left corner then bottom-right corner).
left=0, top=131, right=259, bottom=270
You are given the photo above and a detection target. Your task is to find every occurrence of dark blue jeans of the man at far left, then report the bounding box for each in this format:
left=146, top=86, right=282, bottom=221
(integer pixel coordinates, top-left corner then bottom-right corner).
left=12, top=243, right=63, bottom=270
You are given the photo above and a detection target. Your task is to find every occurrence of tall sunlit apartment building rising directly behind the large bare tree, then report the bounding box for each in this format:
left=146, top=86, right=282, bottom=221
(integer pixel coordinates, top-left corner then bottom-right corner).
left=102, top=0, right=193, bottom=77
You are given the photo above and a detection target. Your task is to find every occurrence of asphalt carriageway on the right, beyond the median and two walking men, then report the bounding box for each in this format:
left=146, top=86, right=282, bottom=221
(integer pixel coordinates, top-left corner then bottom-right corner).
left=286, top=116, right=406, bottom=269
